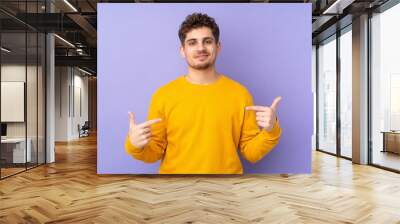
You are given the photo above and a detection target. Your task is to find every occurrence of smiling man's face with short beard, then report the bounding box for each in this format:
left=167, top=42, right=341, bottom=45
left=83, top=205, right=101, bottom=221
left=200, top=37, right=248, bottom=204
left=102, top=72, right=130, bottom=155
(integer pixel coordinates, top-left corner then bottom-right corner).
left=180, top=27, right=221, bottom=70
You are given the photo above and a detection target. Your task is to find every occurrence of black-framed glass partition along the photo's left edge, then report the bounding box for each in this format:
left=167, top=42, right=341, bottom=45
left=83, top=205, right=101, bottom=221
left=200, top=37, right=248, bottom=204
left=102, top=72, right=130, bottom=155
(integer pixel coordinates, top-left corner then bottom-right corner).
left=0, top=1, right=46, bottom=179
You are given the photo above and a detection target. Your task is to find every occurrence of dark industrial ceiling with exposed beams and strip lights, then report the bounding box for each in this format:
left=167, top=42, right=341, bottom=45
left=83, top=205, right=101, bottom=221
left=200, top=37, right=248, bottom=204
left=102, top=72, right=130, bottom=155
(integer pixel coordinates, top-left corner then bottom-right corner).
left=0, top=0, right=394, bottom=73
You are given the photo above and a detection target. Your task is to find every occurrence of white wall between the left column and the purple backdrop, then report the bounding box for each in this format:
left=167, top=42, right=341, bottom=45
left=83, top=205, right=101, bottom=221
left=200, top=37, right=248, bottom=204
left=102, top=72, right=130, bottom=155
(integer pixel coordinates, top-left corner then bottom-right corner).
left=55, top=67, right=88, bottom=141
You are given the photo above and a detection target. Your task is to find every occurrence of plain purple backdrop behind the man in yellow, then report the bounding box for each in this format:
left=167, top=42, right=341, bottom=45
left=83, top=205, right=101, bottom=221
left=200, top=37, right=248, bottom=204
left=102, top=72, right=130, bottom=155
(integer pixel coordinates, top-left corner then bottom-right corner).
left=97, top=3, right=313, bottom=174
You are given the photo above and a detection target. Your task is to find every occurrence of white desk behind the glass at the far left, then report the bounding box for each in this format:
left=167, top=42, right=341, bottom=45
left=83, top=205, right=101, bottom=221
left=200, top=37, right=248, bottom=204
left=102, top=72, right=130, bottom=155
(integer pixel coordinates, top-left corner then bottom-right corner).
left=1, top=138, right=32, bottom=163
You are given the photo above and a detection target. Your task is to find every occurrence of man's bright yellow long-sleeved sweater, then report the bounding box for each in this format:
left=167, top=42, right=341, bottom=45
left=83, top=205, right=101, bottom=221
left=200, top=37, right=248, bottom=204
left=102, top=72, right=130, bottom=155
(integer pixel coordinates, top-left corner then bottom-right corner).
left=125, top=75, right=281, bottom=174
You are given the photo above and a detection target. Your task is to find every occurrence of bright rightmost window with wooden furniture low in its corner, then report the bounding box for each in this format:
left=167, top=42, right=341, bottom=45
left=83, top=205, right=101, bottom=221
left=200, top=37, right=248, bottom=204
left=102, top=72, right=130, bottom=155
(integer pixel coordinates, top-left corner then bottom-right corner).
left=370, top=1, right=400, bottom=170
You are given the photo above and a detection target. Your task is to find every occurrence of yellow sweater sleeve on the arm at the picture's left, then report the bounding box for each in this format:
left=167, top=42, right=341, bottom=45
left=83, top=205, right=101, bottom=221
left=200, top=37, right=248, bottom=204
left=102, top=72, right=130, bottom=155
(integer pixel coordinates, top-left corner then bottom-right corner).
left=125, top=90, right=167, bottom=163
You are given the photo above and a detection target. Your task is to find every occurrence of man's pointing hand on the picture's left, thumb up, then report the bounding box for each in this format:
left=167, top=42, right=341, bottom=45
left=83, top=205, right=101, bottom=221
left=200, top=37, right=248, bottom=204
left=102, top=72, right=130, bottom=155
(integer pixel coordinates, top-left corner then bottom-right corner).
left=128, top=112, right=161, bottom=149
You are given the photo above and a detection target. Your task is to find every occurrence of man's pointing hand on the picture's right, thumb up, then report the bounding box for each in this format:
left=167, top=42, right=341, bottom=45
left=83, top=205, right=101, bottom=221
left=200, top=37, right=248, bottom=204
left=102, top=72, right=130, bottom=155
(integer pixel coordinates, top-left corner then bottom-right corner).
left=246, top=96, right=282, bottom=131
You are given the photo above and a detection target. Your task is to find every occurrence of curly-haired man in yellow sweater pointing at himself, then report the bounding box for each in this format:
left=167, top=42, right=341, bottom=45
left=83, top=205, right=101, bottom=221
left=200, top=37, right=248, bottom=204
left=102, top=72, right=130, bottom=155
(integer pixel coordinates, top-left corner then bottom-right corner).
left=125, top=13, right=281, bottom=174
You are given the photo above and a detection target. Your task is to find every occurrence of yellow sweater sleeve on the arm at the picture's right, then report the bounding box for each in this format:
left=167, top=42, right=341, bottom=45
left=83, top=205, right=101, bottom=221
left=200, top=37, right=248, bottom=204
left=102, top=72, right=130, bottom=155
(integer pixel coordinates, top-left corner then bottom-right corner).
left=239, top=93, right=282, bottom=163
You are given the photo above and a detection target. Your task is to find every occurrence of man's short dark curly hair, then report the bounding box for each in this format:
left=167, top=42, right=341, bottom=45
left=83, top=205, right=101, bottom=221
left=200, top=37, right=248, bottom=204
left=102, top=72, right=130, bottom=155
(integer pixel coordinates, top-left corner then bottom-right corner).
left=178, top=13, right=219, bottom=45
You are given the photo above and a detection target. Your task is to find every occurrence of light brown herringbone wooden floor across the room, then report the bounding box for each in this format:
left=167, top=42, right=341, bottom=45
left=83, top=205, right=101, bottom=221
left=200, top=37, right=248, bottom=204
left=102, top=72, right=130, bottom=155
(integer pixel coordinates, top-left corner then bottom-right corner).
left=0, top=134, right=400, bottom=224
